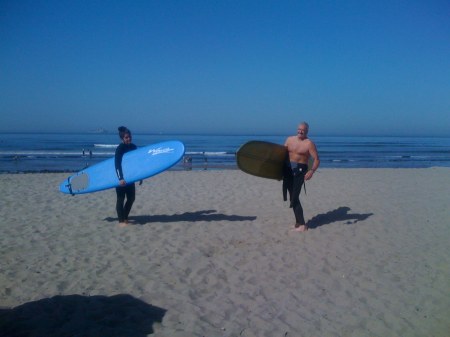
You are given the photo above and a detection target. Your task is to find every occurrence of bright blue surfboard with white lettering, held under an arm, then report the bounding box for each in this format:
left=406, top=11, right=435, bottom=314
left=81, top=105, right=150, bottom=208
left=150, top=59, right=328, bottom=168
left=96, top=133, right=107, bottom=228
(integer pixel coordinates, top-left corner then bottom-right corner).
left=59, top=140, right=184, bottom=194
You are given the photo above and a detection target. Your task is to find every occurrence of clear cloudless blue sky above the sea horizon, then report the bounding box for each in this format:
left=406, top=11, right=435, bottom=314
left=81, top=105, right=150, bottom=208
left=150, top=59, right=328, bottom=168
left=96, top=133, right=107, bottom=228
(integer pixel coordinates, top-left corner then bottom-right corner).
left=0, top=0, right=450, bottom=136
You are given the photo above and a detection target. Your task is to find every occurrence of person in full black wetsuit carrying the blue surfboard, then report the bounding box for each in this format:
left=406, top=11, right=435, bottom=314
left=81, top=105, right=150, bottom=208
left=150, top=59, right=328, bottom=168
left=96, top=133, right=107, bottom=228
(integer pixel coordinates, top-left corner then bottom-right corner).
left=114, top=126, right=142, bottom=227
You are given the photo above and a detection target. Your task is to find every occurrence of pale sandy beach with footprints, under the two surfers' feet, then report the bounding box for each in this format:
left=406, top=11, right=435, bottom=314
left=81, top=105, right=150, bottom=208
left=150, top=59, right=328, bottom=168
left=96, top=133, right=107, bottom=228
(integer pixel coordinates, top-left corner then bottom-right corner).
left=0, top=168, right=450, bottom=337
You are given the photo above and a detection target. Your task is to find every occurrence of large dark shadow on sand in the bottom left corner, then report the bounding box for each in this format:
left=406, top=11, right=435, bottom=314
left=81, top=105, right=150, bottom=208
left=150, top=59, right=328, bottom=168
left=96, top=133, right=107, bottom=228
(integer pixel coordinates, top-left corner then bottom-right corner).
left=0, top=294, right=166, bottom=337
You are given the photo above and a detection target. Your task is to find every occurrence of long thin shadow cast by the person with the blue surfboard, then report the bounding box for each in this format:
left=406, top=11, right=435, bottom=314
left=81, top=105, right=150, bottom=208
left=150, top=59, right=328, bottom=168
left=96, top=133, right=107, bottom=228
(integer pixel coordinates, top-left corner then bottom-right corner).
left=104, top=210, right=256, bottom=225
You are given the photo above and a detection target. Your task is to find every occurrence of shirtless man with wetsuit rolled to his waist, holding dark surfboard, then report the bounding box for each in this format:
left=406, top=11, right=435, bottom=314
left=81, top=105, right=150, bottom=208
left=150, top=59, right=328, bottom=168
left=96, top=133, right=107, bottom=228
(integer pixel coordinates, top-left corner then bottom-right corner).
left=284, top=122, right=320, bottom=232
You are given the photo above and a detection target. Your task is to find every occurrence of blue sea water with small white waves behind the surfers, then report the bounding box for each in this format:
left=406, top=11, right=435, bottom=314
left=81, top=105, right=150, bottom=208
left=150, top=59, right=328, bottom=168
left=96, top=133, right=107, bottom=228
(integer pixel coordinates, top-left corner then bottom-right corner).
left=0, top=133, right=450, bottom=173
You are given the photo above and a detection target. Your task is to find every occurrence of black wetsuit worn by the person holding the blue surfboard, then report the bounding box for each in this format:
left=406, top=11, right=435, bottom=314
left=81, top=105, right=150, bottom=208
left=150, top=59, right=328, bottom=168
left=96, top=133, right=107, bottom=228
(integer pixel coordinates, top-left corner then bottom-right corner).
left=114, top=143, right=137, bottom=222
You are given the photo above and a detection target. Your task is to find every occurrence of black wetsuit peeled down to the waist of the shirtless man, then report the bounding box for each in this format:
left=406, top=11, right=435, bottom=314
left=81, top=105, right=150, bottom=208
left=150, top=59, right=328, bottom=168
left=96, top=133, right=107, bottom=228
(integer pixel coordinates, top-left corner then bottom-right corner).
left=283, top=162, right=308, bottom=226
